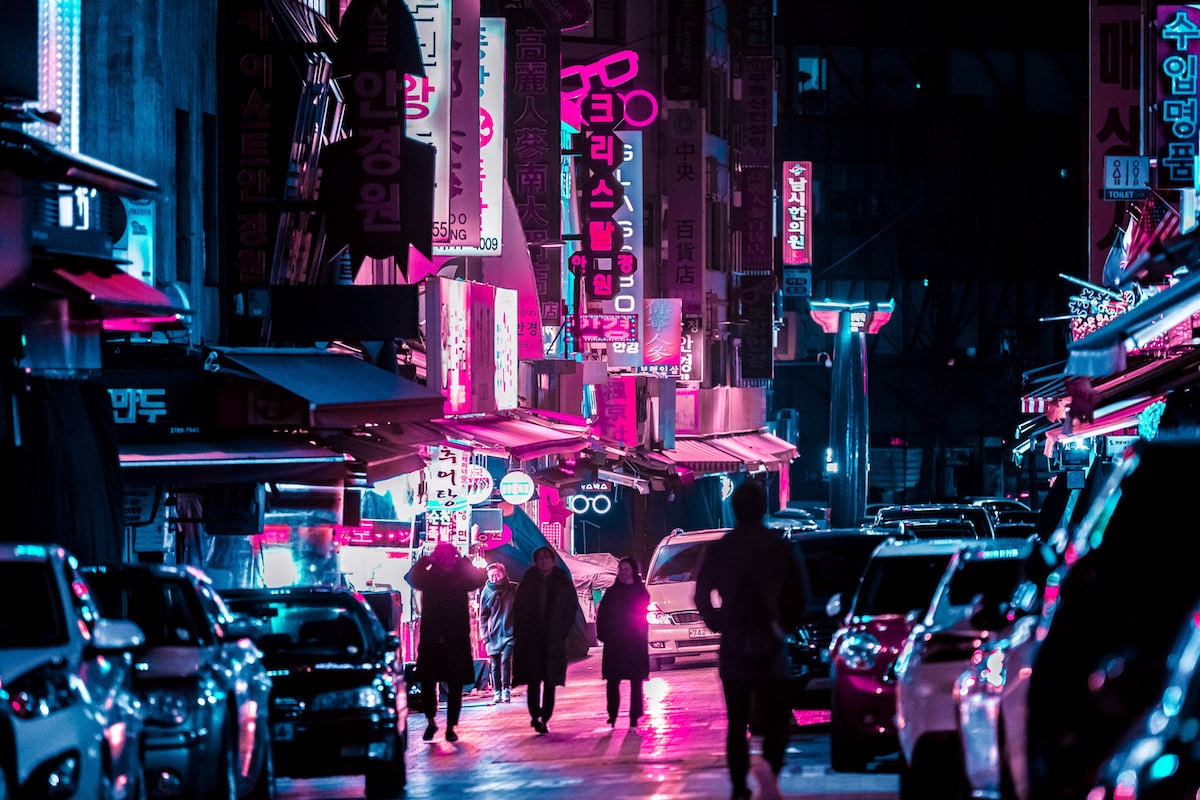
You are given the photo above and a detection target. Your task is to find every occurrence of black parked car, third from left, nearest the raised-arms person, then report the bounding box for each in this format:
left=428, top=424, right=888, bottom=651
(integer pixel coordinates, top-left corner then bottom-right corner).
left=223, top=587, right=408, bottom=798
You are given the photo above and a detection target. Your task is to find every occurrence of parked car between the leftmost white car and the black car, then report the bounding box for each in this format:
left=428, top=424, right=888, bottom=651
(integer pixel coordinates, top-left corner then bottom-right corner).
left=84, top=564, right=275, bottom=800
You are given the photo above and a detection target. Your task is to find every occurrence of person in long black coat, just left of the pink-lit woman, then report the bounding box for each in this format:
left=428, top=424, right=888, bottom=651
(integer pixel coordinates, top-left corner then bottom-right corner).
left=512, top=547, right=580, bottom=734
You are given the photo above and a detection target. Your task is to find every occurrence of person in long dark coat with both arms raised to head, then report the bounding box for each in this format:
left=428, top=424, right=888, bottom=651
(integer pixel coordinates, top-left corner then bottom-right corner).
left=404, top=542, right=487, bottom=741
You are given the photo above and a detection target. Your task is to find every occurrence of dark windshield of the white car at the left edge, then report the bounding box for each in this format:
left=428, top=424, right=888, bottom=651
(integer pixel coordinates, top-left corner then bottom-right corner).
left=0, top=561, right=67, bottom=648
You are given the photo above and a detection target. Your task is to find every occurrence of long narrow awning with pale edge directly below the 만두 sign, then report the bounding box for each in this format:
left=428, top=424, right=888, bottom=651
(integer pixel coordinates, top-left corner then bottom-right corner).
left=120, top=438, right=347, bottom=486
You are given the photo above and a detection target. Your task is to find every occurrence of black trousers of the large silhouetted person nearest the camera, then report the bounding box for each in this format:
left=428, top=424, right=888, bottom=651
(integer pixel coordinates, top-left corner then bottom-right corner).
left=721, top=678, right=792, bottom=790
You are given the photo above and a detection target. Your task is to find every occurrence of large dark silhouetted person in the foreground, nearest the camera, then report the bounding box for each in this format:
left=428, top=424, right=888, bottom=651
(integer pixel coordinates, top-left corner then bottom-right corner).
left=696, top=481, right=809, bottom=800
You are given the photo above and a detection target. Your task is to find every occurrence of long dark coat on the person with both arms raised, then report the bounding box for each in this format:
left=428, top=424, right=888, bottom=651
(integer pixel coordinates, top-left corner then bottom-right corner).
left=404, top=555, right=487, bottom=686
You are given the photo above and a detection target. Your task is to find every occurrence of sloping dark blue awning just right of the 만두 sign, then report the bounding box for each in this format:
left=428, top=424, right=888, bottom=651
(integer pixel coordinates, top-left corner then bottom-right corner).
left=204, top=348, right=444, bottom=429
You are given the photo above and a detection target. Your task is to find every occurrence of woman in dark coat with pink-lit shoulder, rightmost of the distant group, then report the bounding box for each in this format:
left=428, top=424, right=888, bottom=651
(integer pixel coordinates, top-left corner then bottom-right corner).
left=596, top=558, right=650, bottom=728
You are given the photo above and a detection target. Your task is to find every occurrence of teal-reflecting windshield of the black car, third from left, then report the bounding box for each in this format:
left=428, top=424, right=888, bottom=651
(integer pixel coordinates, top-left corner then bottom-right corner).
left=226, top=596, right=372, bottom=663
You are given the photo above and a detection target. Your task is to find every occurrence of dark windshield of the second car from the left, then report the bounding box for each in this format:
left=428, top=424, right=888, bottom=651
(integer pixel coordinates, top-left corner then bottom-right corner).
left=88, top=570, right=214, bottom=648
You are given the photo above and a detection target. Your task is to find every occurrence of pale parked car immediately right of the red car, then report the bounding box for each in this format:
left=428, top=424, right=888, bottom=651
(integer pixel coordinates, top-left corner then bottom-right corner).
left=895, top=539, right=1033, bottom=800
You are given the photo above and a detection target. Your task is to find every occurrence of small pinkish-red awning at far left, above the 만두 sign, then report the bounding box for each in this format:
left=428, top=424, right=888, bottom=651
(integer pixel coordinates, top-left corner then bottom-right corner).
left=34, top=261, right=191, bottom=331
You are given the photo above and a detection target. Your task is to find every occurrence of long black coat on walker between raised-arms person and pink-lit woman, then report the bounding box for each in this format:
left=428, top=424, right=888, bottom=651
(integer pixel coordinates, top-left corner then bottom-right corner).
left=512, top=566, right=580, bottom=686
